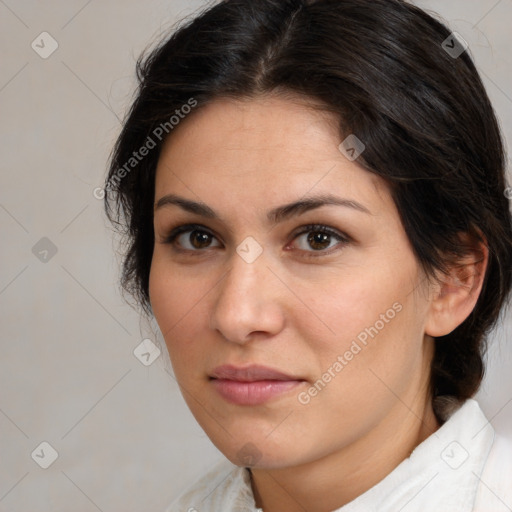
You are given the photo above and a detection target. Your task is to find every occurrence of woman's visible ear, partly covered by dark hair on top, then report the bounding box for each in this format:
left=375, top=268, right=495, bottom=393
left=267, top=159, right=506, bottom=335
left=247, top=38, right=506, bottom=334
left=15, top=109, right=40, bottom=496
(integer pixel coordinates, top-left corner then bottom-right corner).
left=425, top=233, right=489, bottom=337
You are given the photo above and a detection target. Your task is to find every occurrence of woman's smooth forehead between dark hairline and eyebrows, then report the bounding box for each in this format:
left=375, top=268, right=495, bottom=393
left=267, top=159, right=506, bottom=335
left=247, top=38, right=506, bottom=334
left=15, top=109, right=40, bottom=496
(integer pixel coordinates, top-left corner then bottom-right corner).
left=155, top=96, right=390, bottom=216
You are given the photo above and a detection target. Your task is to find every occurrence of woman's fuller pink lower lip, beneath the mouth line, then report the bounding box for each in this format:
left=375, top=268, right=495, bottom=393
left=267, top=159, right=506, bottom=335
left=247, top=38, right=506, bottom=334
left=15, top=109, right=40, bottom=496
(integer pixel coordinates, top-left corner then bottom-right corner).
left=211, top=379, right=303, bottom=405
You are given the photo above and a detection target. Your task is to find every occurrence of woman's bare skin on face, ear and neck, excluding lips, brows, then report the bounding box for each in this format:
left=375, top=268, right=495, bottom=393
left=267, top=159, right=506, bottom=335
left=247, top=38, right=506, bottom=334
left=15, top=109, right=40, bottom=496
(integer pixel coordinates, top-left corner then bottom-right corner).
left=149, top=94, right=486, bottom=512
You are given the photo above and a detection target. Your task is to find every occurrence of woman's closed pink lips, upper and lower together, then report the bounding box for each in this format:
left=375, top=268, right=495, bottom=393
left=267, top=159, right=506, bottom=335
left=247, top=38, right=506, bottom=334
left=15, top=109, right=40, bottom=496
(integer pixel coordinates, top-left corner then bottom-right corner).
left=210, top=365, right=304, bottom=405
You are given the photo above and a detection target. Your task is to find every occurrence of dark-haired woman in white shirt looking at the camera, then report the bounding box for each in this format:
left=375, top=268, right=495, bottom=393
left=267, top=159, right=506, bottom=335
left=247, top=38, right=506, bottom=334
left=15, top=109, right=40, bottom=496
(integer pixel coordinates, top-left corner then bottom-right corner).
left=105, top=0, right=512, bottom=512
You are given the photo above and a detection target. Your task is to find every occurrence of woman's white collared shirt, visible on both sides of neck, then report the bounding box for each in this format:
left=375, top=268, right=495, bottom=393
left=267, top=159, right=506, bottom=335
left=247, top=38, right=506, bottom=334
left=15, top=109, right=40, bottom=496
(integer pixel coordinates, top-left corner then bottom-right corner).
left=166, top=399, right=512, bottom=512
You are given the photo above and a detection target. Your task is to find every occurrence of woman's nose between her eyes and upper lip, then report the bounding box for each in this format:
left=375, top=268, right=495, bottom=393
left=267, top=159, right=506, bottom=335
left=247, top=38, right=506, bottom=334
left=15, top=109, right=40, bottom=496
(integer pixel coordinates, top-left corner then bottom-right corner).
left=210, top=247, right=289, bottom=344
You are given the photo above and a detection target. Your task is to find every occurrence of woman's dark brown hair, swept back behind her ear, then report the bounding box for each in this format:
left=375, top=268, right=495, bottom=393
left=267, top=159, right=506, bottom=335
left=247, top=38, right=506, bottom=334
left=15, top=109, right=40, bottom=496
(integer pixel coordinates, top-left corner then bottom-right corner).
left=105, top=0, right=512, bottom=418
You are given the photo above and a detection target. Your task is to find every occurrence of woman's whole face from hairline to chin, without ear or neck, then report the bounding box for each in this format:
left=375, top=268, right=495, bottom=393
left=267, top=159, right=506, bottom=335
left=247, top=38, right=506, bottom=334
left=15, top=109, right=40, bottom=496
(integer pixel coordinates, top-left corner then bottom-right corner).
left=150, top=96, right=433, bottom=468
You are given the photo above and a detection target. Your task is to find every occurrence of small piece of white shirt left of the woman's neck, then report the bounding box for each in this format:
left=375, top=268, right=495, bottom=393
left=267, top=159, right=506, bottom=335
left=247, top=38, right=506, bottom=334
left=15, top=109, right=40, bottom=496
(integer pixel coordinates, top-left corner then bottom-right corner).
left=165, top=460, right=252, bottom=512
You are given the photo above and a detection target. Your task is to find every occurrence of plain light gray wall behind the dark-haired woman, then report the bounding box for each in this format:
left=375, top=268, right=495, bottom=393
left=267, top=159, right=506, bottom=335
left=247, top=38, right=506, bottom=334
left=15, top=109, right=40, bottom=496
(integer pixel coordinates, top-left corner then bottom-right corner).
left=0, top=0, right=512, bottom=512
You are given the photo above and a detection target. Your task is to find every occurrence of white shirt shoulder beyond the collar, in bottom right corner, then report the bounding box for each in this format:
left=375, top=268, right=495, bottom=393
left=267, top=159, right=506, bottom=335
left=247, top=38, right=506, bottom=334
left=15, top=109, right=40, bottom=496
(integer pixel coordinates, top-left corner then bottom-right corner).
left=474, top=433, right=512, bottom=512
